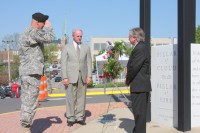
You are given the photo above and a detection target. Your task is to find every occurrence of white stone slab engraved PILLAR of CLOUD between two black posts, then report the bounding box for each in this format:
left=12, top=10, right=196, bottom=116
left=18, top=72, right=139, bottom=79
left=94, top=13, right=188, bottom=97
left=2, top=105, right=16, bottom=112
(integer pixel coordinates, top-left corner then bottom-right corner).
left=151, top=44, right=178, bottom=127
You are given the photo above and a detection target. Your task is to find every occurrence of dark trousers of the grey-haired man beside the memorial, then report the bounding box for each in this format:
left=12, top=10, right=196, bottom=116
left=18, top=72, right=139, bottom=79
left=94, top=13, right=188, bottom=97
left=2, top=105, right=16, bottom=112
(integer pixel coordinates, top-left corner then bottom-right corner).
left=131, top=92, right=149, bottom=133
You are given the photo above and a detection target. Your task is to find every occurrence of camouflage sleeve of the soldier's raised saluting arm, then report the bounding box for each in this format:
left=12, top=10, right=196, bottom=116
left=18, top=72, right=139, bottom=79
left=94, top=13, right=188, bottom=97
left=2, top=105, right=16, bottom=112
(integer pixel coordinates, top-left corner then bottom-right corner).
left=28, top=27, right=55, bottom=45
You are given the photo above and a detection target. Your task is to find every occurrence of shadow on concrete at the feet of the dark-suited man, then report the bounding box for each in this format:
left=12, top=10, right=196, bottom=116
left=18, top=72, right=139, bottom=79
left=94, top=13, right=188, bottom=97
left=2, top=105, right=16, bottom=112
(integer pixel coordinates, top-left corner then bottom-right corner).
left=119, top=118, right=135, bottom=133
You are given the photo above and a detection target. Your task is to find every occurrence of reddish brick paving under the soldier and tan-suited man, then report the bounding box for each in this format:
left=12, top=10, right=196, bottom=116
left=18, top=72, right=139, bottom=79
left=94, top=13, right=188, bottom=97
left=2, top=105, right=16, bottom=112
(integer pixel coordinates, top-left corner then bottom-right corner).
left=0, top=102, right=127, bottom=133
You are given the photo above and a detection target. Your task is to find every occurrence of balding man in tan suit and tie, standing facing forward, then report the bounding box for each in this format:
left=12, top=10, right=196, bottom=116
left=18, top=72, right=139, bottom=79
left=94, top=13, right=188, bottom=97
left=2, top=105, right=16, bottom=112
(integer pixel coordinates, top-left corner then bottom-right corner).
left=61, top=29, right=92, bottom=126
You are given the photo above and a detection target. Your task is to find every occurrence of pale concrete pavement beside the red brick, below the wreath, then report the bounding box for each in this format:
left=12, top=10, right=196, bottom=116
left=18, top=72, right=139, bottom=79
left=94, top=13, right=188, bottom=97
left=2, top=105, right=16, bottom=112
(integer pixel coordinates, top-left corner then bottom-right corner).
left=72, top=108, right=200, bottom=133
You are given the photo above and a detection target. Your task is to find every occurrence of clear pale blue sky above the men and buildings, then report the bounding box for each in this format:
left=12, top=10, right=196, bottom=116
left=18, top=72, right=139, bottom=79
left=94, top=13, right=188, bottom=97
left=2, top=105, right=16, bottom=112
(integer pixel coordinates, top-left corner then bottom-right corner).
left=0, top=0, right=200, bottom=41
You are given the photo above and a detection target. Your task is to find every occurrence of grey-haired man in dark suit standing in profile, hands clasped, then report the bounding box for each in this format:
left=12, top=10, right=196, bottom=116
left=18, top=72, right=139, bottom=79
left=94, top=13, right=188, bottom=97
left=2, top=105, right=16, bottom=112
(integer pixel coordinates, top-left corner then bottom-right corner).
left=126, top=28, right=151, bottom=133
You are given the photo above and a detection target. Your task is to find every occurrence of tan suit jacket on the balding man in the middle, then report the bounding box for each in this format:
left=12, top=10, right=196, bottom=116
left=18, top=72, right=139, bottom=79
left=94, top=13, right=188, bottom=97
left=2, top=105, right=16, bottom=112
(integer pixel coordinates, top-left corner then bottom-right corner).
left=61, top=43, right=92, bottom=83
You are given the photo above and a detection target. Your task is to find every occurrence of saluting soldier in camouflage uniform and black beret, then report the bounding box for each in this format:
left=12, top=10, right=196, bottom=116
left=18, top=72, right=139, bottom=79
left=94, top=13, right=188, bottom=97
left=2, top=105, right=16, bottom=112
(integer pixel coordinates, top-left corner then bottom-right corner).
left=19, top=13, right=54, bottom=132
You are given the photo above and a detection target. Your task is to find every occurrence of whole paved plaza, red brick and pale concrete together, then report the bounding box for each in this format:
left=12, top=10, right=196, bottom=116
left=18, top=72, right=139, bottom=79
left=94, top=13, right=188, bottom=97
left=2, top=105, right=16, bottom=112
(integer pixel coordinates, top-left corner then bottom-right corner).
left=0, top=102, right=200, bottom=133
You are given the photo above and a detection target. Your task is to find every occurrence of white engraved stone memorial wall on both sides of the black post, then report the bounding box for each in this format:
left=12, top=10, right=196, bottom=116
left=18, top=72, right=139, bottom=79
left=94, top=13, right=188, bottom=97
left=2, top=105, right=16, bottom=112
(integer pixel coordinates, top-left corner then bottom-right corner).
left=151, top=44, right=200, bottom=127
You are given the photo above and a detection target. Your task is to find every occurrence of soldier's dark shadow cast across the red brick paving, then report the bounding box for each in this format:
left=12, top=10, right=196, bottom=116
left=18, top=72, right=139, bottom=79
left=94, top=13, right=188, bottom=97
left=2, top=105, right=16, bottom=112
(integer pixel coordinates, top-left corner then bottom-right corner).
left=31, top=116, right=62, bottom=133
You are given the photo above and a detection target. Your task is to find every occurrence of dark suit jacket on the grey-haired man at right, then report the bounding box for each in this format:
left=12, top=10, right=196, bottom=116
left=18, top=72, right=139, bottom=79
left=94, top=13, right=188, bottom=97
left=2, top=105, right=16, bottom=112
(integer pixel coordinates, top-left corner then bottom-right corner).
left=126, top=42, right=151, bottom=92
